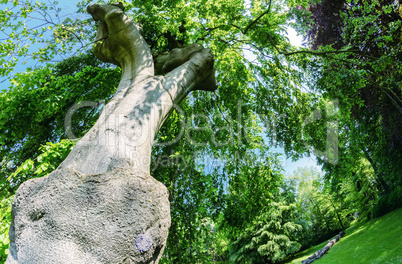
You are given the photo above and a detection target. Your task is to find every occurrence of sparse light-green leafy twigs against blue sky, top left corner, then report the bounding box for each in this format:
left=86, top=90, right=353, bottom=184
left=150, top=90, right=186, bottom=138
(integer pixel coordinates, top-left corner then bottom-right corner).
left=0, top=0, right=90, bottom=76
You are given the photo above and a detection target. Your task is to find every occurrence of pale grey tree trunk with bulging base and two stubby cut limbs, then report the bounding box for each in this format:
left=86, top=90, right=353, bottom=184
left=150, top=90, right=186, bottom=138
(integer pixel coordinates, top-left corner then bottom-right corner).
left=6, top=4, right=216, bottom=264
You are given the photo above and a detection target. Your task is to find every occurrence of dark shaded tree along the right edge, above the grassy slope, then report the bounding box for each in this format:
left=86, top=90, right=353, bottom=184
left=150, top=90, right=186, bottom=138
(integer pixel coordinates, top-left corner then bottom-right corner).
left=308, top=1, right=402, bottom=214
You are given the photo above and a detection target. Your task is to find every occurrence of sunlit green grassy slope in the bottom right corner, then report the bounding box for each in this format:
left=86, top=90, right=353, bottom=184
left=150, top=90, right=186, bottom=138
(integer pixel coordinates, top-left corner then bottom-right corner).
left=287, top=209, right=402, bottom=264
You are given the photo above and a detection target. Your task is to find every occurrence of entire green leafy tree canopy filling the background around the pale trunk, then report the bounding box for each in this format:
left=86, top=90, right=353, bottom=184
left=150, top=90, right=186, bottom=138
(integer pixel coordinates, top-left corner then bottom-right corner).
left=0, top=0, right=402, bottom=263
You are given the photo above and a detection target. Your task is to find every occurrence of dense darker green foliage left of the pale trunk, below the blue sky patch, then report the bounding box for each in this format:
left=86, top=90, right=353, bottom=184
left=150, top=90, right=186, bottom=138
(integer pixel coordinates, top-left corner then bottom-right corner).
left=0, top=54, right=119, bottom=192
